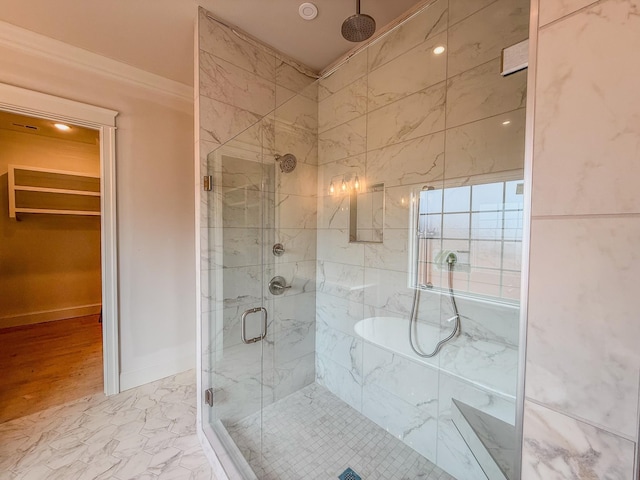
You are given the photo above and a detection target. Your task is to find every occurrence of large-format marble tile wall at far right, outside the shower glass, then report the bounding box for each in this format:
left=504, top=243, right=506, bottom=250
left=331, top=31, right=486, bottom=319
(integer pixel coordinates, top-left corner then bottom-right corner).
left=522, top=0, right=640, bottom=479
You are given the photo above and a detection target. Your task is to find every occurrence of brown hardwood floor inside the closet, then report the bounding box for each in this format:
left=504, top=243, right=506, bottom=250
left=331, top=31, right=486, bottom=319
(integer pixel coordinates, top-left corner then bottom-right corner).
left=0, top=315, right=103, bottom=423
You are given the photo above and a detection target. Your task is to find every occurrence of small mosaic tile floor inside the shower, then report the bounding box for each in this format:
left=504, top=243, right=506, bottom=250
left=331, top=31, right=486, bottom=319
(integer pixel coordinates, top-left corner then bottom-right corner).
left=227, top=384, right=455, bottom=480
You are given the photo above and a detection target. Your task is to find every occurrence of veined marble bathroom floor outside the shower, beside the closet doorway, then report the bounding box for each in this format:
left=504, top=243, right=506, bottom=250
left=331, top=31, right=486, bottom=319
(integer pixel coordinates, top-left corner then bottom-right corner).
left=0, top=371, right=215, bottom=480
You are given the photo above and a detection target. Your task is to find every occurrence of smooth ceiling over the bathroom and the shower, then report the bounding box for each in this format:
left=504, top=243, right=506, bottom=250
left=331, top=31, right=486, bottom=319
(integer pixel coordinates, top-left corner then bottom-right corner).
left=0, top=0, right=419, bottom=85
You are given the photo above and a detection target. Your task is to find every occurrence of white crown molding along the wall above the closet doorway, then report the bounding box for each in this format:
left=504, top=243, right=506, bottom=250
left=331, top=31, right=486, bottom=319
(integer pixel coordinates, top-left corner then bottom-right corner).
left=0, top=21, right=193, bottom=101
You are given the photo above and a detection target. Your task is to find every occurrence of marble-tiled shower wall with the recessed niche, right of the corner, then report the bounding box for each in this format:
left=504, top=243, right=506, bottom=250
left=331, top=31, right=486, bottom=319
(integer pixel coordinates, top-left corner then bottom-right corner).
left=316, top=0, right=529, bottom=479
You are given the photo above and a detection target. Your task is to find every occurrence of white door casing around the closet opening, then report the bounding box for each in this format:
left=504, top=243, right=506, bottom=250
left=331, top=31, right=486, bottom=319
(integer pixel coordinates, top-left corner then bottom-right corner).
left=0, top=83, right=120, bottom=395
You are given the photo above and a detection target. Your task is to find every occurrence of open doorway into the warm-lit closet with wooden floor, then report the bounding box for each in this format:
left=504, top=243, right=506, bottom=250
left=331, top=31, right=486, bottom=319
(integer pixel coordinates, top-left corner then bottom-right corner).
left=0, top=111, right=104, bottom=422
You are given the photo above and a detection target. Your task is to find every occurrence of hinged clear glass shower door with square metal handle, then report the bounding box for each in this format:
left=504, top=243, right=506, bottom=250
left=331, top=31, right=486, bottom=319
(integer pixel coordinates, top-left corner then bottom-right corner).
left=203, top=125, right=273, bottom=479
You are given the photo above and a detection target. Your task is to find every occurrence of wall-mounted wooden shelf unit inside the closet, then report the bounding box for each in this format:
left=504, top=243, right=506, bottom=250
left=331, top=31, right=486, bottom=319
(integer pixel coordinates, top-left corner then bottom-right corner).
left=8, top=165, right=100, bottom=218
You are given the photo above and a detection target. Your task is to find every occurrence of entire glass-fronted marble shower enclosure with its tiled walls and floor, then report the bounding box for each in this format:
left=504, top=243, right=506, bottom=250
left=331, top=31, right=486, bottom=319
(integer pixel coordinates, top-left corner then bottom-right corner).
left=198, top=0, right=528, bottom=480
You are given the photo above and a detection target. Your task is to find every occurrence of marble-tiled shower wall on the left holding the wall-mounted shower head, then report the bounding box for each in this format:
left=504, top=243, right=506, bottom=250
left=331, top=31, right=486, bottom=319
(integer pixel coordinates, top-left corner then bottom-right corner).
left=197, top=9, right=318, bottom=425
